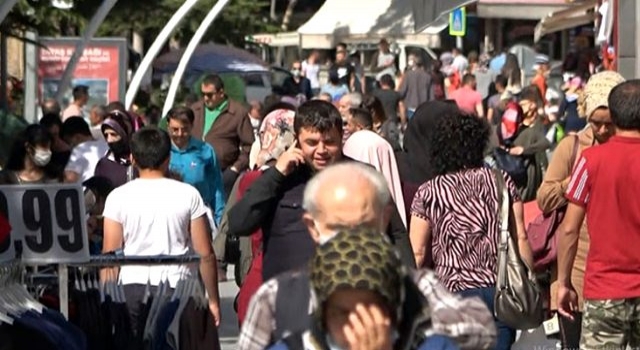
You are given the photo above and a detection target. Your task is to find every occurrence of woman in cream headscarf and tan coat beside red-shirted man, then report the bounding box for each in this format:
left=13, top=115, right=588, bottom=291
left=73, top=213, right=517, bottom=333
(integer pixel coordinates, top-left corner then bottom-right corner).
left=537, top=71, right=625, bottom=349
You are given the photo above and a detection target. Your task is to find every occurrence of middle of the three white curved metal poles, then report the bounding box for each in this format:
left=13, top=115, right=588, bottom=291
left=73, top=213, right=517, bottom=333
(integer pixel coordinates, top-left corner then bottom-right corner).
left=124, top=0, right=198, bottom=109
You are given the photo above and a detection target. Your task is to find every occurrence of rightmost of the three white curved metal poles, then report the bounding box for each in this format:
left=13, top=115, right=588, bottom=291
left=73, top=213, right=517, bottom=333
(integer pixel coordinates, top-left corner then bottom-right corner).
left=162, top=0, right=229, bottom=117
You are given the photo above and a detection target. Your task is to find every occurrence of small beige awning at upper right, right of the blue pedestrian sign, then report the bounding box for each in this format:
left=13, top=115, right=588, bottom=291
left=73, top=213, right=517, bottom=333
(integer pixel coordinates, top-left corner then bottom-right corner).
left=533, top=0, right=598, bottom=42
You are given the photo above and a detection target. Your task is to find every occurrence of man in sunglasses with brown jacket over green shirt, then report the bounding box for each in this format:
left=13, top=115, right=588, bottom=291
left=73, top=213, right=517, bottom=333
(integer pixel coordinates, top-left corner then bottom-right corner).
left=191, top=74, right=254, bottom=197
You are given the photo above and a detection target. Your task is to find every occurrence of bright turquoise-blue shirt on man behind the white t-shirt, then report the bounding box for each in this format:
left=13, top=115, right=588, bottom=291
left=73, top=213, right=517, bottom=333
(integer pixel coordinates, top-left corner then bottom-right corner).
left=169, top=137, right=225, bottom=225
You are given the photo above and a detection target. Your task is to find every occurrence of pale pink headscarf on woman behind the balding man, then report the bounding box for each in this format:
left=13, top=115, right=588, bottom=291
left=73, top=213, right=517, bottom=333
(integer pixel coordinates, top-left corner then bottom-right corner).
left=342, top=130, right=407, bottom=227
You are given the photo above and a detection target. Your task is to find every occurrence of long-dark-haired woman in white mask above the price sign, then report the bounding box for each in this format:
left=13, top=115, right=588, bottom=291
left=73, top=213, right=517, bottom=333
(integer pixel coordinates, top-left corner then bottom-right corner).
left=0, top=124, right=61, bottom=185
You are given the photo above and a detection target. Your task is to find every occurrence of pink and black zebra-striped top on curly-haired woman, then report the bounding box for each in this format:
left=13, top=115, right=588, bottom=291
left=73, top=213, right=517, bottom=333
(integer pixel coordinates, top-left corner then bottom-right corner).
left=411, top=168, right=520, bottom=292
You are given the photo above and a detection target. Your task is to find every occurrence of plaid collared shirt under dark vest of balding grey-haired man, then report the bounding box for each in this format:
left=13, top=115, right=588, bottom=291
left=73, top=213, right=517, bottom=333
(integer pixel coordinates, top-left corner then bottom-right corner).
left=238, top=270, right=496, bottom=350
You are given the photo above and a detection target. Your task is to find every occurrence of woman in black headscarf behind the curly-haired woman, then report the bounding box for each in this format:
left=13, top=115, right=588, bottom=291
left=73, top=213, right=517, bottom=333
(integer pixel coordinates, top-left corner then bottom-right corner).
left=396, top=100, right=459, bottom=223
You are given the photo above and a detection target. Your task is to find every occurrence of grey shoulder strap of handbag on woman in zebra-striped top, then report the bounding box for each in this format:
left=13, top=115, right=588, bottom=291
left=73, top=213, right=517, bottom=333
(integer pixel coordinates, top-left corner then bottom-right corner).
left=493, top=169, right=511, bottom=289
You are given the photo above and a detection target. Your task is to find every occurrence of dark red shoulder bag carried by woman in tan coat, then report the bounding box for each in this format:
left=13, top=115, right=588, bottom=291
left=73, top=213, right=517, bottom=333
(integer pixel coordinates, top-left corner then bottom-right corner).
left=527, top=136, right=580, bottom=272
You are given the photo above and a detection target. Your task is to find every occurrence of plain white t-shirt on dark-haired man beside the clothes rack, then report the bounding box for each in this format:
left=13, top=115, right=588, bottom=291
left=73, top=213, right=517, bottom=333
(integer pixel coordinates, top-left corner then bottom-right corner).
left=103, top=178, right=207, bottom=287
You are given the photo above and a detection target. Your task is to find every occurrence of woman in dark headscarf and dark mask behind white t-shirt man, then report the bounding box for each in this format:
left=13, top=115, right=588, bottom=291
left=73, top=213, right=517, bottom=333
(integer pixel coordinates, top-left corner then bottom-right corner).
left=94, top=110, right=135, bottom=188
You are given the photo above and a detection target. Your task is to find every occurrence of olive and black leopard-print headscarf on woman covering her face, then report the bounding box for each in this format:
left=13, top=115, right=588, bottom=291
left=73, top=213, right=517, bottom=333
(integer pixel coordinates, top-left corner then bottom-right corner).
left=310, top=228, right=405, bottom=327
